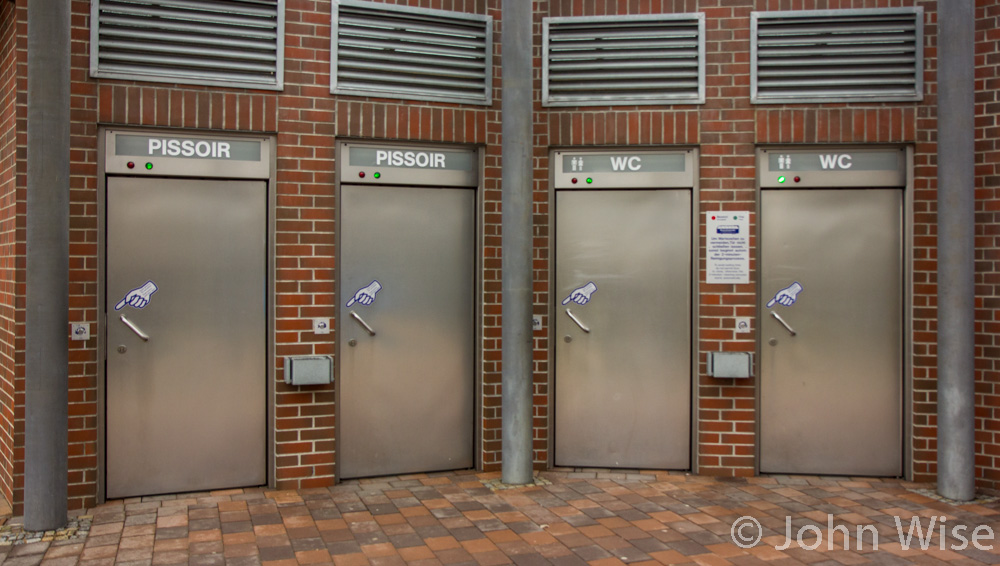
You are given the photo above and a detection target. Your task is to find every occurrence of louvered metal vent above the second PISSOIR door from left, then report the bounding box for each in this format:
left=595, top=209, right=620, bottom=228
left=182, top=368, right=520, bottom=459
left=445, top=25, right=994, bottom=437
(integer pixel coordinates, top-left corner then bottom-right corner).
left=331, top=1, right=493, bottom=104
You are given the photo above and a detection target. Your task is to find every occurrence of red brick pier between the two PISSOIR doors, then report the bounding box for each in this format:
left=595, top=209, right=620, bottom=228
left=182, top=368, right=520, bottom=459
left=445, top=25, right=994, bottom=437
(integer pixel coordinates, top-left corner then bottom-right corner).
left=274, top=2, right=337, bottom=487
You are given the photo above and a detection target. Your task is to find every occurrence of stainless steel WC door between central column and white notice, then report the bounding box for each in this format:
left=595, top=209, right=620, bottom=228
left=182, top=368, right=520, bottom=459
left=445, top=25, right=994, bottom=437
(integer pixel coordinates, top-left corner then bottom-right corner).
left=555, top=190, right=691, bottom=469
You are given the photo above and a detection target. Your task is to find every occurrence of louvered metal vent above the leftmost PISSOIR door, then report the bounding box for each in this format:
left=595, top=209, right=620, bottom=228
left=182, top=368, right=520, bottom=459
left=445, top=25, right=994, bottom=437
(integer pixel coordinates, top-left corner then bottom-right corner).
left=91, top=0, right=284, bottom=90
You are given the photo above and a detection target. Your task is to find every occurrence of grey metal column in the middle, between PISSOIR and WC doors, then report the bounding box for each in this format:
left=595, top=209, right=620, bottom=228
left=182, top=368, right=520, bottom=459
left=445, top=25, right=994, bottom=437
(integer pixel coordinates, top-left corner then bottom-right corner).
left=501, top=0, right=533, bottom=484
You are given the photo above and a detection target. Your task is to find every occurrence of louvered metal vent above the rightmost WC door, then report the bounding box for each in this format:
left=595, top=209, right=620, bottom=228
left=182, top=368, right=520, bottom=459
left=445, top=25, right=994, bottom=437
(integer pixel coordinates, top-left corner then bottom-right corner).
left=751, top=8, right=923, bottom=102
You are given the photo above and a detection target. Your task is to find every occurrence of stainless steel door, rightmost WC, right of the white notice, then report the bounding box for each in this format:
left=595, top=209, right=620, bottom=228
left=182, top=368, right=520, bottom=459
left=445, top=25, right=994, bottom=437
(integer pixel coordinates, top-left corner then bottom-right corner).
left=760, top=189, right=903, bottom=476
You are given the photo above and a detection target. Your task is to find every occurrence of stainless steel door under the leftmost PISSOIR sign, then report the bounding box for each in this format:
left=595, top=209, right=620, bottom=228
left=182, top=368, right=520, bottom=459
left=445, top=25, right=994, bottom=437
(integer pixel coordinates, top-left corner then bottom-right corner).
left=106, top=178, right=267, bottom=497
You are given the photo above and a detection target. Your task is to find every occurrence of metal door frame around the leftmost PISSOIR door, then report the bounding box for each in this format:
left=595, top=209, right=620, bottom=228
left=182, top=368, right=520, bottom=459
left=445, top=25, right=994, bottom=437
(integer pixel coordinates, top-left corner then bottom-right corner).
left=95, top=129, right=277, bottom=504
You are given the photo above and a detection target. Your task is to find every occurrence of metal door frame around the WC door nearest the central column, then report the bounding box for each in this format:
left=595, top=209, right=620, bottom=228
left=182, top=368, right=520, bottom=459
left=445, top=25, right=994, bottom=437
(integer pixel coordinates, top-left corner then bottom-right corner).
left=542, top=145, right=701, bottom=474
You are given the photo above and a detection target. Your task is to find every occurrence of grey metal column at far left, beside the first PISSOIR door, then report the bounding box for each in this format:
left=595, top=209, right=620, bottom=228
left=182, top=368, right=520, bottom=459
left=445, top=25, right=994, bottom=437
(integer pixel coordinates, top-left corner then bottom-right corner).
left=24, top=0, right=70, bottom=531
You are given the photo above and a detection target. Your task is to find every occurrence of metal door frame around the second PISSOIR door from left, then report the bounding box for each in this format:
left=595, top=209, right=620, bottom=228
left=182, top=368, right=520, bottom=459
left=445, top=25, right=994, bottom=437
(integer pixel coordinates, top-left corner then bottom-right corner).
left=333, top=138, right=486, bottom=483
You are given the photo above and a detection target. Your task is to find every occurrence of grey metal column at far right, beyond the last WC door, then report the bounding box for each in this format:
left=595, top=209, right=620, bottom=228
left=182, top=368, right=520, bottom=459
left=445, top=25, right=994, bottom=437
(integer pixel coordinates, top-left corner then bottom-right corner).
left=937, top=0, right=976, bottom=501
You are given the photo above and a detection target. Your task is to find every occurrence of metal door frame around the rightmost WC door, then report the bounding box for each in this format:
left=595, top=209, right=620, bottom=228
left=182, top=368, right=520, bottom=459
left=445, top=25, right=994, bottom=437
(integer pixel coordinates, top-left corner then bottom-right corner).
left=754, top=144, right=914, bottom=481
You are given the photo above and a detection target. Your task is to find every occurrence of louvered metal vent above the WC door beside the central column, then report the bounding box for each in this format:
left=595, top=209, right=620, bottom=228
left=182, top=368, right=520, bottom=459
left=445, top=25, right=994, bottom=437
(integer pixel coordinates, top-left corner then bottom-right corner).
left=542, top=14, right=705, bottom=106
